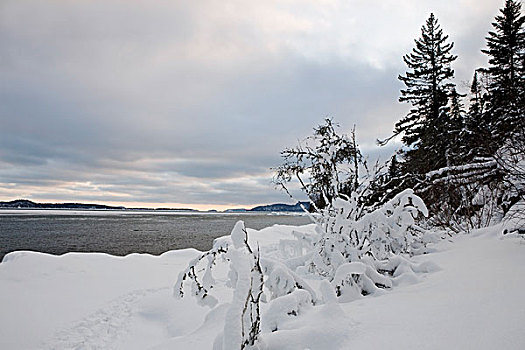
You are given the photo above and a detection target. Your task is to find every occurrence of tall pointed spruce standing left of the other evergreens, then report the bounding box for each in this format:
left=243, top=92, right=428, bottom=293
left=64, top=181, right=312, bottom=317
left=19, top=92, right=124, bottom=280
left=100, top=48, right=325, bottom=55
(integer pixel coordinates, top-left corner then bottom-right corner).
left=394, top=14, right=457, bottom=174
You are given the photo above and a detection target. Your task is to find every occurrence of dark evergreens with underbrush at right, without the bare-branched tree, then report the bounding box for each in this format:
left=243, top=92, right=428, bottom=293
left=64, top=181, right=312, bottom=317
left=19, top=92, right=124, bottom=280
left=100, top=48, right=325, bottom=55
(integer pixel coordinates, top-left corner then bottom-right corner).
left=380, top=0, right=525, bottom=228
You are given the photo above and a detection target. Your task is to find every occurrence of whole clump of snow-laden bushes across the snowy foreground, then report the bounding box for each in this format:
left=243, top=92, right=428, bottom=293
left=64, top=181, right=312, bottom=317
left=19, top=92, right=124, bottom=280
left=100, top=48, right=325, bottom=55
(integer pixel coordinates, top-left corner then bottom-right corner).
left=175, top=190, right=428, bottom=350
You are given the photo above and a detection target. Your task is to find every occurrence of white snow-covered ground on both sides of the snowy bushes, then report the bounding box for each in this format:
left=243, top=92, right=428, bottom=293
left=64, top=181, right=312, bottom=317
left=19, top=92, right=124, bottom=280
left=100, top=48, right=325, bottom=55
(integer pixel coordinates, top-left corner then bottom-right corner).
left=0, top=225, right=525, bottom=350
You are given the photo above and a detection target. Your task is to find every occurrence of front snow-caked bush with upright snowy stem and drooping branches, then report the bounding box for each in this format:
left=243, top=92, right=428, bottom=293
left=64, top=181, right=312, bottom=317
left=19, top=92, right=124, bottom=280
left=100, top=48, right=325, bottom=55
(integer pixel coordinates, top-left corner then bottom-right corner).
left=174, top=221, right=316, bottom=349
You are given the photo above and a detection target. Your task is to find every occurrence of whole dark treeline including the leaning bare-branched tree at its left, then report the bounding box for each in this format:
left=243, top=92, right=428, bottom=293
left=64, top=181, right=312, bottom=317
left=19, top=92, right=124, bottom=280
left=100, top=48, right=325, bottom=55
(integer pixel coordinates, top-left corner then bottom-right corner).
left=275, top=0, right=525, bottom=234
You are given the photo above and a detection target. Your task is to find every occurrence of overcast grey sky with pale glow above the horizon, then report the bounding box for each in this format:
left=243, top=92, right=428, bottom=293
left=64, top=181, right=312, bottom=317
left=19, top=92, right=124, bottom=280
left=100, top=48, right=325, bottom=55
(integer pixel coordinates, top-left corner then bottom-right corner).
left=0, top=0, right=504, bottom=209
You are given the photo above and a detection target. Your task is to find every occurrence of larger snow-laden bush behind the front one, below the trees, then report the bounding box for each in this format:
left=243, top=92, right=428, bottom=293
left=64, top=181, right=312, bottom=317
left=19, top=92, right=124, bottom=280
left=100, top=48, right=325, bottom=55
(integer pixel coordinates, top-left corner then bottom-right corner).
left=281, top=189, right=428, bottom=301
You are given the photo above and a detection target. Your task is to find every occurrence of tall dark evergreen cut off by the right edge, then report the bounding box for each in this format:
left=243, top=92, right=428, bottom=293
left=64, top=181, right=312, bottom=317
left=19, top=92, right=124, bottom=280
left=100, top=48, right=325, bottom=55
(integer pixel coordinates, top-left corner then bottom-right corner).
left=482, top=0, right=525, bottom=142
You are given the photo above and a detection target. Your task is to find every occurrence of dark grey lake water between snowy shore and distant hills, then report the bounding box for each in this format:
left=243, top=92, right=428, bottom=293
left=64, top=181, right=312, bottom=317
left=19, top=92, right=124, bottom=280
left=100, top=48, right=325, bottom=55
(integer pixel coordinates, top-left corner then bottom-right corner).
left=0, top=210, right=311, bottom=261
